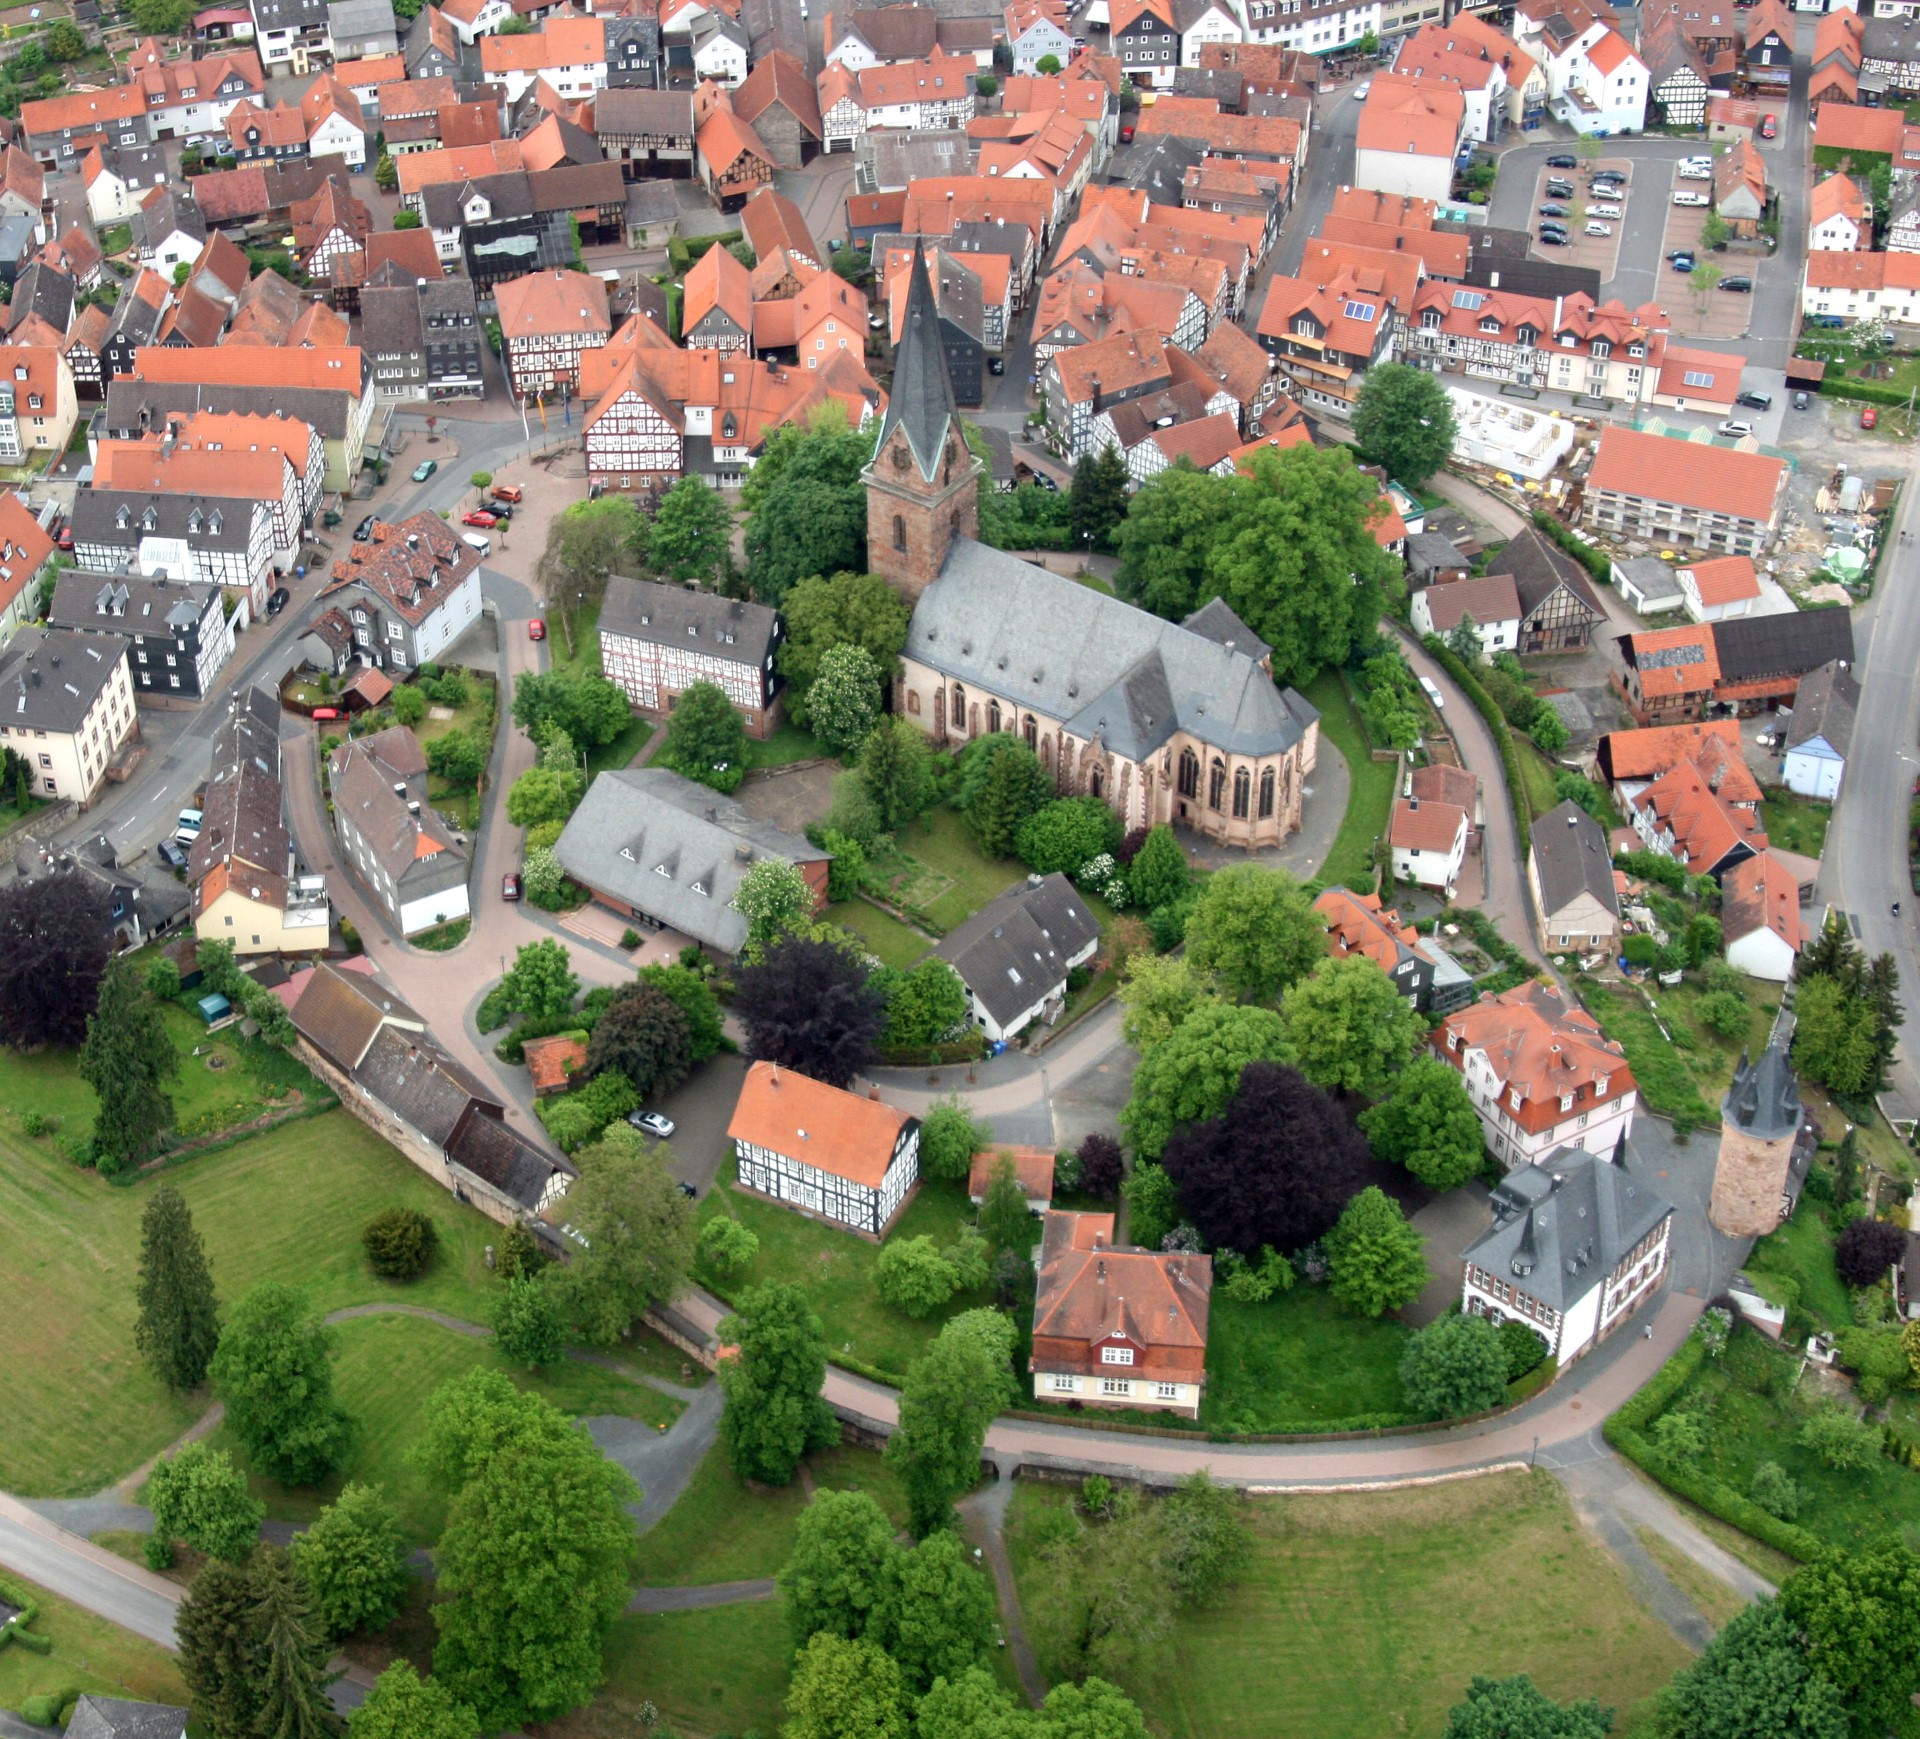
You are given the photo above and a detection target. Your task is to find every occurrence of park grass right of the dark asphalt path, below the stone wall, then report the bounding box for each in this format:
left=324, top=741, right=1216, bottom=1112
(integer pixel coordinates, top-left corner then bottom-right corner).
left=634, top=1443, right=906, bottom=1587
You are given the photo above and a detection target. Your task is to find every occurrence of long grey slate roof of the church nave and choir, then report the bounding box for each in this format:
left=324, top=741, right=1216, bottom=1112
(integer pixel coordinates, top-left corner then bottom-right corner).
left=906, top=537, right=1319, bottom=760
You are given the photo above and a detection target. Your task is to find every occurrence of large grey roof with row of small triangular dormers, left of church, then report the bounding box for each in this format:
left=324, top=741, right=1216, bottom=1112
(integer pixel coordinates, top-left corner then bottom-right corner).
left=553, top=768, right=831, bottom=954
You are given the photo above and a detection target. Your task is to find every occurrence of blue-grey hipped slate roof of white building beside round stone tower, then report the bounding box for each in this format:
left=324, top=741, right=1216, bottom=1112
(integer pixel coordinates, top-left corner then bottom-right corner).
left=1465, top=1136, right=1672, bottom=1311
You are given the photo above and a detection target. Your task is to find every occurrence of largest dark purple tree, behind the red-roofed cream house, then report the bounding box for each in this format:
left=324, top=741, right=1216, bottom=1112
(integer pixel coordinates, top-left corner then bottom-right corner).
left=1162, top=1063, right=1369, bottom=1259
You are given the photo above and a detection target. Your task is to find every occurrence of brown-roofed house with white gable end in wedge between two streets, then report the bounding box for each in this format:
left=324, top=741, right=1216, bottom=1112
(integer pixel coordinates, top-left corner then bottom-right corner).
left=326, top=726, right=472, bottom=937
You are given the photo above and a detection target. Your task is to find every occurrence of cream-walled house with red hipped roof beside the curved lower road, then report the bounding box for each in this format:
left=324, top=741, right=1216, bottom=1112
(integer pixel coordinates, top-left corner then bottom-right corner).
left=1027, top=1213, right=1213, bottom=1418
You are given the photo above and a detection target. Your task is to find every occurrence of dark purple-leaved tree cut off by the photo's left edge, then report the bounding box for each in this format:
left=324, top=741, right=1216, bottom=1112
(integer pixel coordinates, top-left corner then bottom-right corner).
left=0, top=870, right=111, bottom=1050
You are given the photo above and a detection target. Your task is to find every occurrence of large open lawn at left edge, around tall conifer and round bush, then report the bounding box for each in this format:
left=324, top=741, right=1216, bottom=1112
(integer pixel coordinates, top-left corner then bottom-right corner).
left=0, top=1111, right=497, bottom=1497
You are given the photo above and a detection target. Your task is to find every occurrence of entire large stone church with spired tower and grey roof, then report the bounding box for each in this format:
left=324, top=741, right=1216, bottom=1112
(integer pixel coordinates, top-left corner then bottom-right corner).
left=866, top=251, right=1319, bottom=846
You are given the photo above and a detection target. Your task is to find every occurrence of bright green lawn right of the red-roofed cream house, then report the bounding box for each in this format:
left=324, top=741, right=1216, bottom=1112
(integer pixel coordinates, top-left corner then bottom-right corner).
left=1200, top=1286, right=1407, bottom=1432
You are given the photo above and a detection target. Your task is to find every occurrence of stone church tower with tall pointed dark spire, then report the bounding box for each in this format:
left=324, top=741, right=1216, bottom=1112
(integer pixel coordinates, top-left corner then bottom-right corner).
left=862, top=246, right=981, bottom=603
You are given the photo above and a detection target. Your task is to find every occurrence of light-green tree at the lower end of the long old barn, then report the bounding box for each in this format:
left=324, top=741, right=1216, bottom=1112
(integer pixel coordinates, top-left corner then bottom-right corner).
left=551, top=1123, right=699, bottom=1346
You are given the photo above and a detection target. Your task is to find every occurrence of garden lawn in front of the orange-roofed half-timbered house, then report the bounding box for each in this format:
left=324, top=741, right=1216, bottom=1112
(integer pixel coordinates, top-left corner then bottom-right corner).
left=699, top=1159, right=989, bottom=1376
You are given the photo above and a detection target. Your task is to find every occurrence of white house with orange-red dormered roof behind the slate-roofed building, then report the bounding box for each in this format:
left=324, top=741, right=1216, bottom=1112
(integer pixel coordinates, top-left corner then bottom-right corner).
left=1434, top=979, right=1640, bottom=1165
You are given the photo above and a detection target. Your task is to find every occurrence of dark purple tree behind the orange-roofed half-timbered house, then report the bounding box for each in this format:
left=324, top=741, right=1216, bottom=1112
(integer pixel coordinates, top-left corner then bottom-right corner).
left=733, top=937, right=887, bottom=1086
